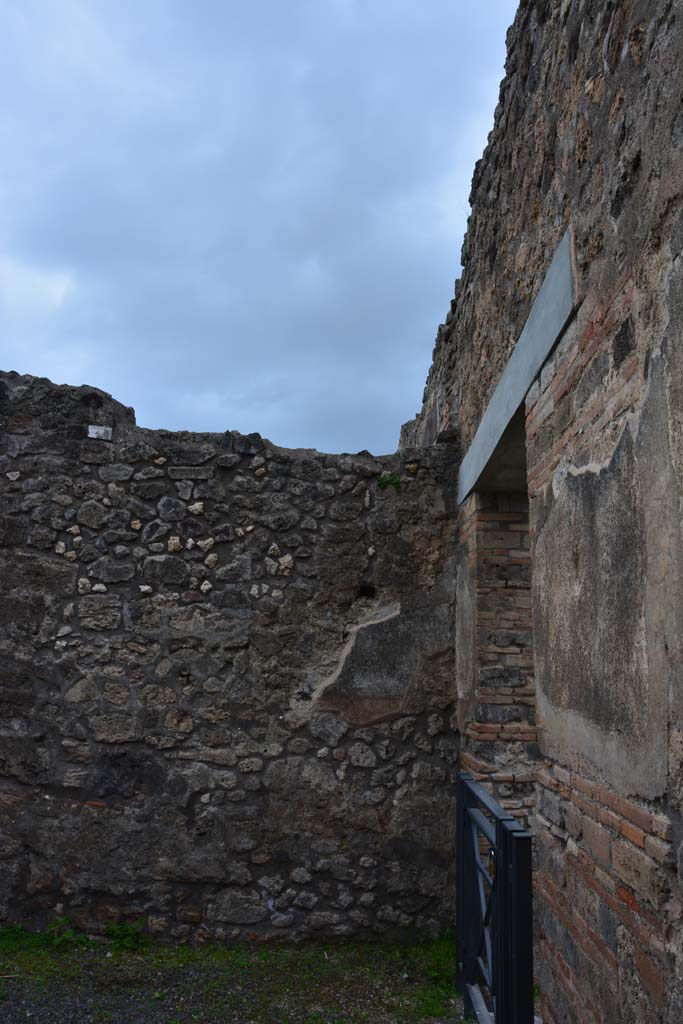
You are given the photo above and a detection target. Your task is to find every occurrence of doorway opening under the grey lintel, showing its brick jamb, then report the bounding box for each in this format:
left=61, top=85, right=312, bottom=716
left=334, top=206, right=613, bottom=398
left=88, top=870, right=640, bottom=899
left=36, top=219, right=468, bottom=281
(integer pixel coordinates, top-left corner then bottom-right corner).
left=456, top=406, right=539, bottom=825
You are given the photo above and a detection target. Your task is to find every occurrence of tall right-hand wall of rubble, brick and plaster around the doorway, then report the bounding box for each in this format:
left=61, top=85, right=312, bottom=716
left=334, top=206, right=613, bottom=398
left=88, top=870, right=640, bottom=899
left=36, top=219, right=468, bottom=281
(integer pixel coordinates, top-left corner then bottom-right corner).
left=403, top=0, right=683, bottom=1024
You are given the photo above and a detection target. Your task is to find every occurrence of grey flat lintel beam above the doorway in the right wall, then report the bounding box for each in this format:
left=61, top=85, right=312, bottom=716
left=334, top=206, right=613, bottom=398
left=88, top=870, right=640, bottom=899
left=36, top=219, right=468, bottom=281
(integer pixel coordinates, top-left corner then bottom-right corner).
left=458, top=228, right=577, bottom=502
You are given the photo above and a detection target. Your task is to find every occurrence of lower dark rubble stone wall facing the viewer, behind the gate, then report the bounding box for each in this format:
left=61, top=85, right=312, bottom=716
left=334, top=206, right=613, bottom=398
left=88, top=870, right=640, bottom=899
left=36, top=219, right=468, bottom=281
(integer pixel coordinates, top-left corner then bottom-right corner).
left=0, top=373, right=458, bottom=939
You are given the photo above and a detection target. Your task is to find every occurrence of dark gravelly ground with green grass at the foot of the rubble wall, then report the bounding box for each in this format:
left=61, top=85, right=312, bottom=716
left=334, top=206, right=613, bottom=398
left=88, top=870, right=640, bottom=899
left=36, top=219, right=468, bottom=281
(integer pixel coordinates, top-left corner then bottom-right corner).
left=0, top=922, right=462, bottom=1024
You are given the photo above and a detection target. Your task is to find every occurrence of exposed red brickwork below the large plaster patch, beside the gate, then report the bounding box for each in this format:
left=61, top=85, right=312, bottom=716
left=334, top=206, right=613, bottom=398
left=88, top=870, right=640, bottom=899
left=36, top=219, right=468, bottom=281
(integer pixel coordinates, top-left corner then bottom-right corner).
left=533, top=761, right=675, bottom=1024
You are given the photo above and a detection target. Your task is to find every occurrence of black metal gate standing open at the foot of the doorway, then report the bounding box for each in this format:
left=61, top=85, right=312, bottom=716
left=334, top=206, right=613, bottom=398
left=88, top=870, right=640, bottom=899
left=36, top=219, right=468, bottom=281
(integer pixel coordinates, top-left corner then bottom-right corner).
left=456, top=772, right=533, bottom=1024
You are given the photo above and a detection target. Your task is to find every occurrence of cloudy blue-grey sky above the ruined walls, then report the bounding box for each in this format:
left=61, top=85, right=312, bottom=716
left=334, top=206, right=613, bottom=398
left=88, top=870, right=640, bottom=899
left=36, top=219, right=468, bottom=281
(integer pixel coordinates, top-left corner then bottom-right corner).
left=0, top=0, right=516, bottom=453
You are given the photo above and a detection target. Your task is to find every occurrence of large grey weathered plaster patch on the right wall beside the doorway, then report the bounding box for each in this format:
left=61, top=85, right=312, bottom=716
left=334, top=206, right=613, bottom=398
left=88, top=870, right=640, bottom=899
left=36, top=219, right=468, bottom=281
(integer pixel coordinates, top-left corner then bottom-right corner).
left=533, top=354, right=683, bottom=798
